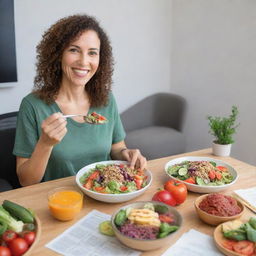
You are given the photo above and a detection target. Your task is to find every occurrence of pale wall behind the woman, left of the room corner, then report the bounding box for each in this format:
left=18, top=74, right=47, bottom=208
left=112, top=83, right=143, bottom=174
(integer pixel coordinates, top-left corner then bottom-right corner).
left=0, top=0, right=171, bottom=114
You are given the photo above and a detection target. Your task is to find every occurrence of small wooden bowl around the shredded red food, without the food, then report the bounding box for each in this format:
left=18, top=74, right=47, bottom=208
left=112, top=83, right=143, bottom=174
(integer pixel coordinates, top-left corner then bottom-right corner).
left=194, top=194, right=245, bottom=226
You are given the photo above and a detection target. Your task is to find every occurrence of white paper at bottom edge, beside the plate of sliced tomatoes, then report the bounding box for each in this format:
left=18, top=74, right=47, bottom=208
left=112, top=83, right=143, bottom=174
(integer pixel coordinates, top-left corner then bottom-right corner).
left=162, top=229, right=224, bottom=256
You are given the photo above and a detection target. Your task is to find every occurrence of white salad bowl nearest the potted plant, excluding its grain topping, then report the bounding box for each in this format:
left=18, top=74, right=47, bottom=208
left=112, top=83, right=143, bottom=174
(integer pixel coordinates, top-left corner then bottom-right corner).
left=165, top=156, right=238, bottom=193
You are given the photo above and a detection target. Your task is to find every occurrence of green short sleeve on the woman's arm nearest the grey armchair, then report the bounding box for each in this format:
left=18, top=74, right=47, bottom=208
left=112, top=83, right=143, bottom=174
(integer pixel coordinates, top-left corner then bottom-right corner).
left=110, top=93, right=125, bottom=144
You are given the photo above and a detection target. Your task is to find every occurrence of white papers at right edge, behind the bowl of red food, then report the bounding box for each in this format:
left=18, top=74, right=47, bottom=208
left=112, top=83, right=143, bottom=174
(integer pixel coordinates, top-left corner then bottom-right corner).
left=234, top=187, right=256, bottom=213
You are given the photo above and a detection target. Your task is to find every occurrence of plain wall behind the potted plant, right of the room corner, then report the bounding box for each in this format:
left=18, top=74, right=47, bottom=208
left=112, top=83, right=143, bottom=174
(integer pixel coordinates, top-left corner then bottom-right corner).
left=171, top=0, right=256, bottom=164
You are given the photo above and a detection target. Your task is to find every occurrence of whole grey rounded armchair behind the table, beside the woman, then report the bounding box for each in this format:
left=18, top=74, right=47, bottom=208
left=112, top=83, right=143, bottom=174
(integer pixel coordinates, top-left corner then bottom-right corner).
left=121, top=93, right=187, bottom=160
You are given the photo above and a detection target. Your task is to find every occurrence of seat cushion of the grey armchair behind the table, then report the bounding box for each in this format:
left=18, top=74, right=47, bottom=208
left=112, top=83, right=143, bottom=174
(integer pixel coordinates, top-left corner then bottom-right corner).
left=125, top=126, right=185, bottom=160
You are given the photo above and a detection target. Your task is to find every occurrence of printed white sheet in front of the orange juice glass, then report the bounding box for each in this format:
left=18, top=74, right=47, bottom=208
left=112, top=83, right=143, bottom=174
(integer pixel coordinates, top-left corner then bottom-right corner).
left=45, top=210, right=141, bottom=256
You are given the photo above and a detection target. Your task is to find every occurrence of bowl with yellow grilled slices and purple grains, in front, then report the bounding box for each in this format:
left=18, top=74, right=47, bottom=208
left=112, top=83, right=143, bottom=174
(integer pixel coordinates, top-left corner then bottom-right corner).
left=111, top=201, right=182, bottom=251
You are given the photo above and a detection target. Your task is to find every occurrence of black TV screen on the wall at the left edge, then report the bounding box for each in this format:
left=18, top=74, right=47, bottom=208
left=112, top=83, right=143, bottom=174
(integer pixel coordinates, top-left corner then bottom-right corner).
left=0, top=0, right=17, bottom=83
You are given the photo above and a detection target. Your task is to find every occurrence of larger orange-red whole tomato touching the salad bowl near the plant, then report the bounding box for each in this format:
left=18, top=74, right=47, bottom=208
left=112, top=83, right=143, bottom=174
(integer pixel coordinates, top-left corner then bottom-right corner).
left=164, top=180, right=188, bottom=204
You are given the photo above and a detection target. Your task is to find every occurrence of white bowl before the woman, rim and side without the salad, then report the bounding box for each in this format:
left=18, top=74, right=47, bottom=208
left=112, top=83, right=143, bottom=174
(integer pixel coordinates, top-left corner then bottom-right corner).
left=76, top=161, right=152, bottom=203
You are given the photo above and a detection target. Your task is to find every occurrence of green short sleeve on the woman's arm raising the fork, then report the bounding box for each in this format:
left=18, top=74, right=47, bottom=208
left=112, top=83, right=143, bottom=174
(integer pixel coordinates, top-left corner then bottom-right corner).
left=13, top=98, right=39, bottom=158
